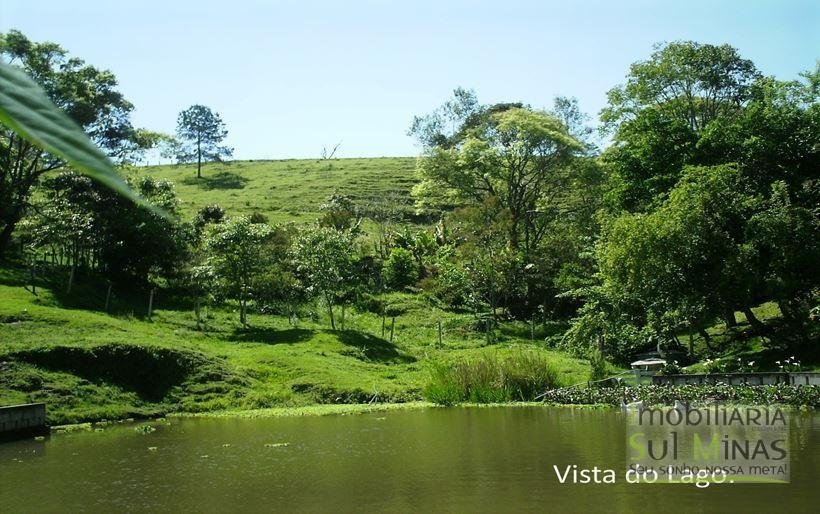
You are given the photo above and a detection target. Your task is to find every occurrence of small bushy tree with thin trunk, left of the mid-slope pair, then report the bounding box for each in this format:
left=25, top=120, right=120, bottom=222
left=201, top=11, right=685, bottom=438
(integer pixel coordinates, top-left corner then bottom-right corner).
left=205, top=216, right=274, bottom=328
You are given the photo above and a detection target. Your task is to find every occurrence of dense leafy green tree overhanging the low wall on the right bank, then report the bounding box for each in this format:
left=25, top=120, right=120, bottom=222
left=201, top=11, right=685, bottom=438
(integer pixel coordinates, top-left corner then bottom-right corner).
left=599, top=165, right=820, bottom=348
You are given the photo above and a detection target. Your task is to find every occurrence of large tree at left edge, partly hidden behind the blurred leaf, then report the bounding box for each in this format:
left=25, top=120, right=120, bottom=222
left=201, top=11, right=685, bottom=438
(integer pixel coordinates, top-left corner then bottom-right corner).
left=0, top=30, right=136, bottom=256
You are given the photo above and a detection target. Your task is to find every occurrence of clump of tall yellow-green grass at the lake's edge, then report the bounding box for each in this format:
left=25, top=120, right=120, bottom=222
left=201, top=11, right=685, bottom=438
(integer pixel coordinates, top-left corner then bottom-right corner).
left=424, top=352, right=558, bottom=405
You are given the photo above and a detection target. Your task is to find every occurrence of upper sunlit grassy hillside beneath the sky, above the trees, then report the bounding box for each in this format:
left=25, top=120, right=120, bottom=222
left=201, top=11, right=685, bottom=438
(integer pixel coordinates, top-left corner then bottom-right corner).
left=131, top=157, right=416, bottom=223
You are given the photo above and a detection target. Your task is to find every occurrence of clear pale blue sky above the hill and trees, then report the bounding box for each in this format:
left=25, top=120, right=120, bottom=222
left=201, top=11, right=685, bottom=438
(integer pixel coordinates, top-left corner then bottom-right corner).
left=0, top=0, right=820, bottom=159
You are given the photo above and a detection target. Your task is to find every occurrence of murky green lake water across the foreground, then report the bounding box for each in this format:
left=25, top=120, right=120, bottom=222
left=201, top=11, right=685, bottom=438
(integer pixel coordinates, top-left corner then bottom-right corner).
left=0, top=407, right=820, bottom=513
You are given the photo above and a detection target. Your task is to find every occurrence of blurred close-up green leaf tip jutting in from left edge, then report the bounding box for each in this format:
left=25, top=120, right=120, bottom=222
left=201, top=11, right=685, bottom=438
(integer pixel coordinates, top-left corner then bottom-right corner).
left=0, top=62, right=171, bottom=218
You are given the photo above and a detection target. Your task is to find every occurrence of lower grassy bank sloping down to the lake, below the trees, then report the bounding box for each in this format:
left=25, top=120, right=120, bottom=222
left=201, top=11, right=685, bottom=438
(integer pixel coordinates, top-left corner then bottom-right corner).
left=0, top=267, right=589, bottom=423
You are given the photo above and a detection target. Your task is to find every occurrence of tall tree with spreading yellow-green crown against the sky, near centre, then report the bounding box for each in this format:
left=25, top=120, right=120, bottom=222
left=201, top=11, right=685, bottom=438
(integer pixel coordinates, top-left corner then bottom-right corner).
left=411, top=95, right=583, bottom=255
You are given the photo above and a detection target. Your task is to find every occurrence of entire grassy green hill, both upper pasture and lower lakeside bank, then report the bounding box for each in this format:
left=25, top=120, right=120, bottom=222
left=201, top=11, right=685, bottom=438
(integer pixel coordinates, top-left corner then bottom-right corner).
left=0, top=158, right=600, bottom=423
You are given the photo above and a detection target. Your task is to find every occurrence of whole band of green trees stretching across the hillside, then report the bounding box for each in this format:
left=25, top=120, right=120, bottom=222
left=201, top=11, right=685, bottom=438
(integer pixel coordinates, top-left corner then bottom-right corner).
left=0, top=31, right=820, bottom=361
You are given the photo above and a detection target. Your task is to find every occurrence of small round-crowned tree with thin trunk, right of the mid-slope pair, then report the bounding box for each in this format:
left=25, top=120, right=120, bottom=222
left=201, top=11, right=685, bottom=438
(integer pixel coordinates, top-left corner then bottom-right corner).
left=292, top=227, right=356, bottom=330
